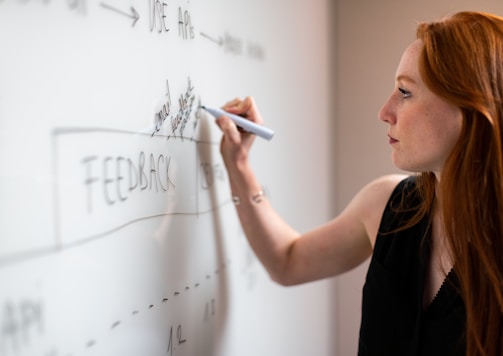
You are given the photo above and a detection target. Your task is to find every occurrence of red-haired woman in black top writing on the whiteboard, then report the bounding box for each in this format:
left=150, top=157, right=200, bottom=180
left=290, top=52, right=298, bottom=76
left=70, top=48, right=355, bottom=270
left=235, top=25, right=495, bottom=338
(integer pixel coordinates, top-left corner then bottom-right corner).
left=217, top=12, right=503, bottom=356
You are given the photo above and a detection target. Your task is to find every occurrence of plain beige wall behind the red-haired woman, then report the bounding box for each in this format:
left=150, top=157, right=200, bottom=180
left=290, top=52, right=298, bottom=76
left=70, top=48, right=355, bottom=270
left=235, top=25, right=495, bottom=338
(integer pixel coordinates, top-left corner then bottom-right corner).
left=332, top=0, right=503, bottom=356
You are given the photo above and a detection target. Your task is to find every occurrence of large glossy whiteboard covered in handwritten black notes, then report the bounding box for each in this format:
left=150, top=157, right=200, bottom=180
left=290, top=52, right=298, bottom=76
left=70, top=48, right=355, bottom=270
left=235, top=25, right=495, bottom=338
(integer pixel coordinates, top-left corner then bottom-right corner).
left=0, top=0, right=334, bottom=356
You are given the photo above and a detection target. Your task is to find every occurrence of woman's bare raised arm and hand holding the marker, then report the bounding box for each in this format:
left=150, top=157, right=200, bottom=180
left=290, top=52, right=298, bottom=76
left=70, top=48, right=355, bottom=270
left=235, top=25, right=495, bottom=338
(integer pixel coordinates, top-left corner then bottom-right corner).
left=217, top=97, right=403, bottom=285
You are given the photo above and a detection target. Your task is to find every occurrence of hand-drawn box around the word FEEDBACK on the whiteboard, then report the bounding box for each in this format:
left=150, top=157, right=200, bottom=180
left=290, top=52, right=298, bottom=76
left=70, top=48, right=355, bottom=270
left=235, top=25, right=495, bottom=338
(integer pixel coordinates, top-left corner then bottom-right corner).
left=53, top=128, right=220, bottom=247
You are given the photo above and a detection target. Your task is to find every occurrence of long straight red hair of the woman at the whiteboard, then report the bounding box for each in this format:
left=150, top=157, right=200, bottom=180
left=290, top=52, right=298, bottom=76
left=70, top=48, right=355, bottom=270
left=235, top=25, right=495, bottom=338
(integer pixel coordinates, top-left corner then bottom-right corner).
left=416, top=12, right=503, bottom=356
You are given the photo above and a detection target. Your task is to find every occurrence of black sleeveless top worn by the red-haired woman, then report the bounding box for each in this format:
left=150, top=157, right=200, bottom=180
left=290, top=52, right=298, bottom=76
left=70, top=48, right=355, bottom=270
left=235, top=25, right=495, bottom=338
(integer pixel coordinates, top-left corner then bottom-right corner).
left=358, top=177, right=466, bottom=356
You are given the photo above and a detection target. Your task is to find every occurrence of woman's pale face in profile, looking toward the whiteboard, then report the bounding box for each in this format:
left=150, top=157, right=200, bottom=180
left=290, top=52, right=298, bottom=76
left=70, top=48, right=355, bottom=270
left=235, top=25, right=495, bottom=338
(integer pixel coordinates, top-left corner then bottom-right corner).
left=379, top=40, right=462, bottom=178
